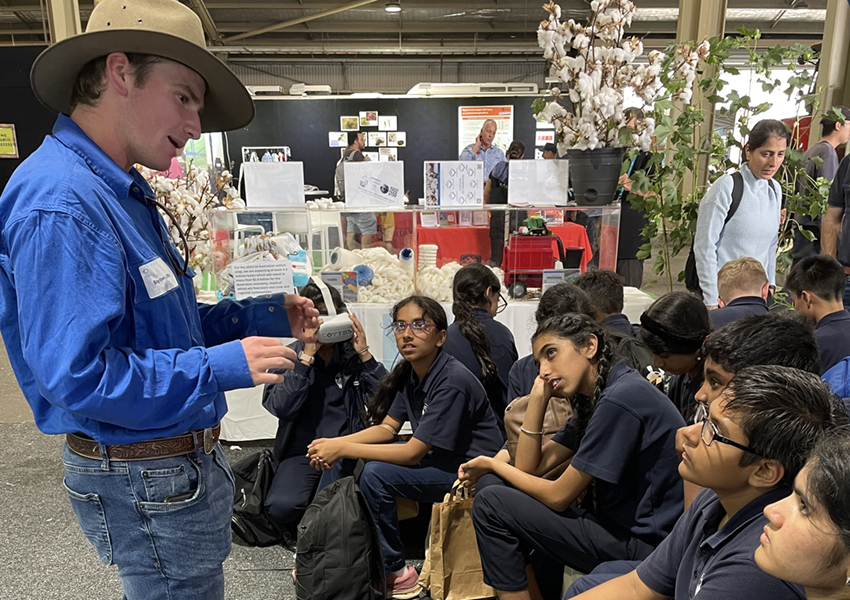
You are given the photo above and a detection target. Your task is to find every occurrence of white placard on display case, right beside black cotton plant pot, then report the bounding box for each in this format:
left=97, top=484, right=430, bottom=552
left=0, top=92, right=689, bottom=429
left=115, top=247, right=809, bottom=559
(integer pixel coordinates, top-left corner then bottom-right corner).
left=508, top=160, right=570, bottom=206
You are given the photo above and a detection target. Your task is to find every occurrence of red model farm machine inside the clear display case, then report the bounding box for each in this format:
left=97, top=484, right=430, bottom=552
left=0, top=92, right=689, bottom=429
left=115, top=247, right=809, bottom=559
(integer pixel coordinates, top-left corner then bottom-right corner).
left=502, top=217, right=584, bottom=298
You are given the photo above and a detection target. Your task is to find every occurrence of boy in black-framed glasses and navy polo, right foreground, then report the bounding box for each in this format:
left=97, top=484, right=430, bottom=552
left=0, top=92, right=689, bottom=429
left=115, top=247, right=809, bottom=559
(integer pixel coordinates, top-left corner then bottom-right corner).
left=565, top=366, right=836, bottom=600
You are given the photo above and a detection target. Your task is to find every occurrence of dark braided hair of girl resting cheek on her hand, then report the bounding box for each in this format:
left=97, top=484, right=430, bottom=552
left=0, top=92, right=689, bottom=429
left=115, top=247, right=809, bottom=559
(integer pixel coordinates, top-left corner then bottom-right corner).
left=531, top=313, right=614, bottom=439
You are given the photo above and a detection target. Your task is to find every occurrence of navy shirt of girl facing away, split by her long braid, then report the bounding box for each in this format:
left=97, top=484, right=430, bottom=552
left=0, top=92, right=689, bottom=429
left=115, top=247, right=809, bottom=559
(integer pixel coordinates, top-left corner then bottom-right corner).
left=443, top=308, right=519, bottom=420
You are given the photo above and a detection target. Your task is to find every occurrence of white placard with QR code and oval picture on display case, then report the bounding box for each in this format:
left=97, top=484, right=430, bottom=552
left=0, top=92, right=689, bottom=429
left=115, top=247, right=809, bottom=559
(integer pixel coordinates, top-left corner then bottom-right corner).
left=343, top=161, right=404, bottom=208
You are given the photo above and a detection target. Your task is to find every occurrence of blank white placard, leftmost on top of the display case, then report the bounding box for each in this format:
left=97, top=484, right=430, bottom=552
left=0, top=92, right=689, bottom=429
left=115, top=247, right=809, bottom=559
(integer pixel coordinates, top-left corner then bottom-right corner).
left=240, top=161, right=304, bottom=209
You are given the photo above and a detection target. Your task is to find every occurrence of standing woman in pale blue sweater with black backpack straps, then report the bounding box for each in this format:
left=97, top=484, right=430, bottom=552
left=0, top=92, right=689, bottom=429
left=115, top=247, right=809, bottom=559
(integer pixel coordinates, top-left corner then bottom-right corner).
left=694, top=119, right=789, bottom=309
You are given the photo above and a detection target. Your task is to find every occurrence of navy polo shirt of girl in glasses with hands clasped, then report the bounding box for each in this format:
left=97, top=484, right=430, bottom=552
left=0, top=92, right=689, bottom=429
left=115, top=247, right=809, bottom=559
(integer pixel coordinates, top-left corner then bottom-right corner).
left=389, top=351, right=504, bottom=464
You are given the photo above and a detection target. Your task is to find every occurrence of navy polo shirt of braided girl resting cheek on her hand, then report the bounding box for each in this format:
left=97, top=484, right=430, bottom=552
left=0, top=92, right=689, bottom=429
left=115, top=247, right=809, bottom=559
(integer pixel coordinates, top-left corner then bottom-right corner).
left=552, top=361, right=685, bottom=545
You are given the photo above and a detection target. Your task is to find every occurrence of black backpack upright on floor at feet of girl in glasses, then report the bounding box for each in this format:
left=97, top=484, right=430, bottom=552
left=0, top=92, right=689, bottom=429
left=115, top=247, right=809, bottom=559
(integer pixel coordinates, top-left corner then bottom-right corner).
left=295, top=477, right=386, bottom=600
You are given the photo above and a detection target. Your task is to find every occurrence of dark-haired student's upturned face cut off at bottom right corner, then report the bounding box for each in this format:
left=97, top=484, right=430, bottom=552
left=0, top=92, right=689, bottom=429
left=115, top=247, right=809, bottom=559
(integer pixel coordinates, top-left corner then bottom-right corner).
left=755, top=430, right=850, bottom=600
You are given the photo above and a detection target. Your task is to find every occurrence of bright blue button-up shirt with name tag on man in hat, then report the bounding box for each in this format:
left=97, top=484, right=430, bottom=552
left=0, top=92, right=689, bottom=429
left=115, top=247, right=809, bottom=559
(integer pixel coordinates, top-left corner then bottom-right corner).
left=0, top=115, right=290, bottom=444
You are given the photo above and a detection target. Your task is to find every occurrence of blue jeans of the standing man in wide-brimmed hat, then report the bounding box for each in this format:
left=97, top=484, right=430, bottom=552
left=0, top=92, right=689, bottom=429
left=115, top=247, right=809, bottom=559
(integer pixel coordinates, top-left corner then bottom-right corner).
left=63, top=444, right=233, bottom=600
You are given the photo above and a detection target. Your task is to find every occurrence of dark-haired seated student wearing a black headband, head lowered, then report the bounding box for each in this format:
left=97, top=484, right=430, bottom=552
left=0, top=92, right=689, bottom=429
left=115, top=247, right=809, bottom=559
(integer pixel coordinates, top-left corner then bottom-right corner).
left=640, top=292, right=711, bottom=423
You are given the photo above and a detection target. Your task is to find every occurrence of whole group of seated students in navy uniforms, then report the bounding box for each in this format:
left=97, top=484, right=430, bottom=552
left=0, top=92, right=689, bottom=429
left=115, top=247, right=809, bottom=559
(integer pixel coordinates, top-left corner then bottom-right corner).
left=263, top=256, right=850, bottom=600
